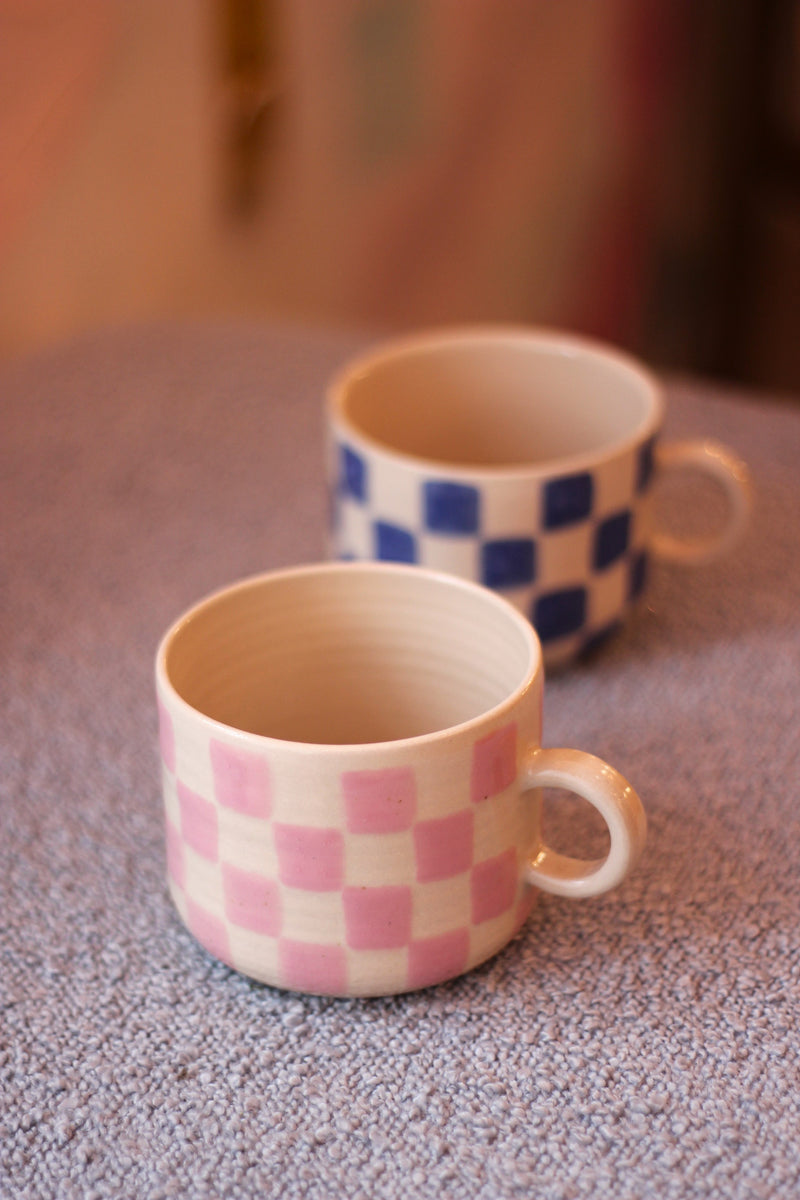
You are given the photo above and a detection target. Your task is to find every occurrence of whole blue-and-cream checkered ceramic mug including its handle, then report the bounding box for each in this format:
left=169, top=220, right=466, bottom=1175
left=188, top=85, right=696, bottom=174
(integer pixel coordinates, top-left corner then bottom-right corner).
left=327, top=326, right=748, bottom=665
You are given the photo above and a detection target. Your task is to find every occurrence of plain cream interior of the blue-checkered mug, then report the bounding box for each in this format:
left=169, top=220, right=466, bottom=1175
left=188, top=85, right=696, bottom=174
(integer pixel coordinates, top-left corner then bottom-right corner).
left=333, top=331, right=660, bottom=467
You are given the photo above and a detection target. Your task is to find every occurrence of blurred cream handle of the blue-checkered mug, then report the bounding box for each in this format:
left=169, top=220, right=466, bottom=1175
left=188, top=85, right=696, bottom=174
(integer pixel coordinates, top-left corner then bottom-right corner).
left=650, top=438, right=752, bottom=566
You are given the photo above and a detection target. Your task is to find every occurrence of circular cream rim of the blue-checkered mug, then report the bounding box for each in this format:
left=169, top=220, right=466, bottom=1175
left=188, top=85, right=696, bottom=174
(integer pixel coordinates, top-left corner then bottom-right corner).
left=326, top=323, right=664, bottom=481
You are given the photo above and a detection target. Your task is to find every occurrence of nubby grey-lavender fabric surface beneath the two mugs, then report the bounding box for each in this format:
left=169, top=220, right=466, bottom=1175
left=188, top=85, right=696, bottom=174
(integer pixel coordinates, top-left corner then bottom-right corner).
left=0, top=325, right=800, bottom=1200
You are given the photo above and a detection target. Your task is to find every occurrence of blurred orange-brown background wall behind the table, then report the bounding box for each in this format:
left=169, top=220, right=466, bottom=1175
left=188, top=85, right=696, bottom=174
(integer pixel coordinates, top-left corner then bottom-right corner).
left=0, top=0, right=800, bottom=391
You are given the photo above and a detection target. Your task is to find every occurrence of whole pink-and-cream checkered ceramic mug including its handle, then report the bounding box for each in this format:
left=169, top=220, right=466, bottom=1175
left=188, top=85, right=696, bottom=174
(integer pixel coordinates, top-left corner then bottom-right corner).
left=156, top=563, right=645, bottom=996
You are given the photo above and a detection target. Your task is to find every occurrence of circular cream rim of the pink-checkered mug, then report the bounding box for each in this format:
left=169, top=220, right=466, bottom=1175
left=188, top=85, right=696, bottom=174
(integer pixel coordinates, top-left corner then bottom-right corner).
left=155, top=560, right=543, bottom=756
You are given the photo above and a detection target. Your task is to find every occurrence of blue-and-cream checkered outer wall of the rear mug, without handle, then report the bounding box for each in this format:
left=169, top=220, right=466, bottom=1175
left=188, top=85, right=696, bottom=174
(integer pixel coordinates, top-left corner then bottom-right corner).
left=332, top=440, right=654, bottom=661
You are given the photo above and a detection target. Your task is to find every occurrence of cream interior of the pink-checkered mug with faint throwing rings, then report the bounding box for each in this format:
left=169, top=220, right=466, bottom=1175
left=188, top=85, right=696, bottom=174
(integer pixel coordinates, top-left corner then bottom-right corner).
left=158, top=564, right=539, bottom=744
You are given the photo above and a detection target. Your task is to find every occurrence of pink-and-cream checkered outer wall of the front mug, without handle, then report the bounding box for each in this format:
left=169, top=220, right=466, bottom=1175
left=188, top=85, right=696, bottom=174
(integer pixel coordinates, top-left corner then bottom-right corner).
left=160, top=706, right=534, bottom=995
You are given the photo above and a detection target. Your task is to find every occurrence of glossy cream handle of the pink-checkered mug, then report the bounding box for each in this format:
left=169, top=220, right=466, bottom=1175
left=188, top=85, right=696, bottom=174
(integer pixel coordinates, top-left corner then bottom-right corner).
left=523, top=748, right=648, bottom=899
